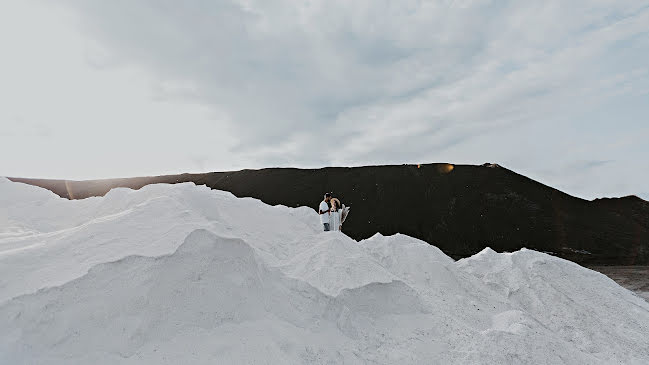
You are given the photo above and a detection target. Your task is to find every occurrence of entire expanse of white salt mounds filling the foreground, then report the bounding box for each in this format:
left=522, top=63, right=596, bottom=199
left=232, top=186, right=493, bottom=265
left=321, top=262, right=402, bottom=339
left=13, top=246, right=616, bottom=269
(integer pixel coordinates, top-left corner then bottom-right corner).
left=0, top=179, right=649, bottom=364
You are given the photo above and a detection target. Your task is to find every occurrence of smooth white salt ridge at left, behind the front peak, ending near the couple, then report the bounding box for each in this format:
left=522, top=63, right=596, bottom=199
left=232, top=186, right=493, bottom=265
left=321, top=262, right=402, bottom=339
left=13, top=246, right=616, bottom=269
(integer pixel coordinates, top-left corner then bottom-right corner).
left=0, top=179, right=315, bottom=303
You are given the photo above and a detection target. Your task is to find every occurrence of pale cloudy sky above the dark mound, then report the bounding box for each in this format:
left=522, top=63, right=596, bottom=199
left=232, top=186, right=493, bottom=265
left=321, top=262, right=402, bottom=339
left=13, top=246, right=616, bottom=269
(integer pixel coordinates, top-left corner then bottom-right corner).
left=0, top=0, right=649, bottom=200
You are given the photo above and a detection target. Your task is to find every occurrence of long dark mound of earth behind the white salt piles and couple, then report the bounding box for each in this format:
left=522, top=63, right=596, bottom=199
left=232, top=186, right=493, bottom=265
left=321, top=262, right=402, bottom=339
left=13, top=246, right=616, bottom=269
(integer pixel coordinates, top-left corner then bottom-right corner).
left=11, top=164, right=649, bottom=265
